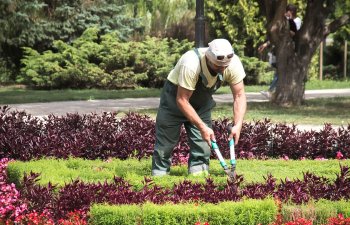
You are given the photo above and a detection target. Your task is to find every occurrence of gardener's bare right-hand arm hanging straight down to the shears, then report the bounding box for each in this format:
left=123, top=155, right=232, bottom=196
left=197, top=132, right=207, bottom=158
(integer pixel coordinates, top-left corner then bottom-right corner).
left=229, top=81, right=247, bottom=143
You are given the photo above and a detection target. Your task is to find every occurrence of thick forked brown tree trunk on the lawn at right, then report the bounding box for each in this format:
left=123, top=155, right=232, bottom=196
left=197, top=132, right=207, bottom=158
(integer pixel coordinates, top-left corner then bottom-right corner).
left=259, top=0, right=349, bottom=106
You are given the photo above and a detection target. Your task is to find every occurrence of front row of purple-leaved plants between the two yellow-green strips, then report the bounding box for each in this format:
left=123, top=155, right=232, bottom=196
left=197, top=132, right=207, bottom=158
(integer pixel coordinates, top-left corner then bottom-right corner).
left=2, top=157, right=350, bottom=222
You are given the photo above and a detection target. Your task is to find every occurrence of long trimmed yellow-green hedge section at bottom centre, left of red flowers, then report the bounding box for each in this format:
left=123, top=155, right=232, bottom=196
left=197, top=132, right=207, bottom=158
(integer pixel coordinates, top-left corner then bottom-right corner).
left=90, top=199, right=277, bottom=225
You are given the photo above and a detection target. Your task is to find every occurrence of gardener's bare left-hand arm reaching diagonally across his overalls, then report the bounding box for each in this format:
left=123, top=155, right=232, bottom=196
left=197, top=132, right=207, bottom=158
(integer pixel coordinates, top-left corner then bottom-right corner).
left=176, top=86, right=215, bottom=146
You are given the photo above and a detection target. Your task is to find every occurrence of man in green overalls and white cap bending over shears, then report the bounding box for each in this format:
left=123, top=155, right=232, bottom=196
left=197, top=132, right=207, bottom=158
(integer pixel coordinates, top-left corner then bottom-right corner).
left=152, top=39, right=247, bottom=176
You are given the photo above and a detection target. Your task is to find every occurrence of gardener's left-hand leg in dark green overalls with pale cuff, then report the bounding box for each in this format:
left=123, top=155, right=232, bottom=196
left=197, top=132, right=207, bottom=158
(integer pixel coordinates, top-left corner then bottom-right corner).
left=152, top=109, right=182, bottom=176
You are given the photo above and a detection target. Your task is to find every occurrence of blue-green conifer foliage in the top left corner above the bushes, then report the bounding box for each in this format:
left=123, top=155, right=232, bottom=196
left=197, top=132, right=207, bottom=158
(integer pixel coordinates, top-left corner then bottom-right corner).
left=0, top=0, right=143, bottom=78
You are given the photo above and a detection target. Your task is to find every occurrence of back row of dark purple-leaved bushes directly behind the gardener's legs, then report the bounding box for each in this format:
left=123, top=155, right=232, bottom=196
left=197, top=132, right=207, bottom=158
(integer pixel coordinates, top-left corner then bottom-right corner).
left=0, top=106, right=350, bottom=164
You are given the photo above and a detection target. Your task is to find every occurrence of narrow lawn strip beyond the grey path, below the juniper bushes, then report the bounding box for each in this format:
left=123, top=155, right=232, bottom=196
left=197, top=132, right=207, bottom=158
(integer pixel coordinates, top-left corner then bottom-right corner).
left=0, top=80, right=350, bottom=104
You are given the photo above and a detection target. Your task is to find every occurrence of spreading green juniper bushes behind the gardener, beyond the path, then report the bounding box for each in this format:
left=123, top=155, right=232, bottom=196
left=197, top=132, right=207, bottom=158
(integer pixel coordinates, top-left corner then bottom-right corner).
left=17, top=28, right=272, bottom=89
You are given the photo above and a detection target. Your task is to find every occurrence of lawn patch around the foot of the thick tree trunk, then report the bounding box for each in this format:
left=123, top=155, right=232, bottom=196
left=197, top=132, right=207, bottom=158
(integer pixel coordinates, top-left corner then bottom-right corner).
left=138, top=97, right=350, bottom=126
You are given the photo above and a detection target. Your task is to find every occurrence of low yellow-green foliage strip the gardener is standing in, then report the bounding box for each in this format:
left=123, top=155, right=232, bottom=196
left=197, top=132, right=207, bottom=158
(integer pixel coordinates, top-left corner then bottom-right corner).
left=8, top=158, right=350, bottom=190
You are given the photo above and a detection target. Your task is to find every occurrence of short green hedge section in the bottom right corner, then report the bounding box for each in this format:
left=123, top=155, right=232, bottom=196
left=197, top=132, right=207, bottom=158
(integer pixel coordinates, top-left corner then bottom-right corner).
left=282, top=199, right=350, bottom=225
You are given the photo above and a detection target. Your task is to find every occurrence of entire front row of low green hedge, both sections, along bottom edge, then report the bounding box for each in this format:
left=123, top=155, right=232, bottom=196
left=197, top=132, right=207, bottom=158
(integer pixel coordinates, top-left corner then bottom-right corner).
left=90, top=199, right=350, bottom=225
